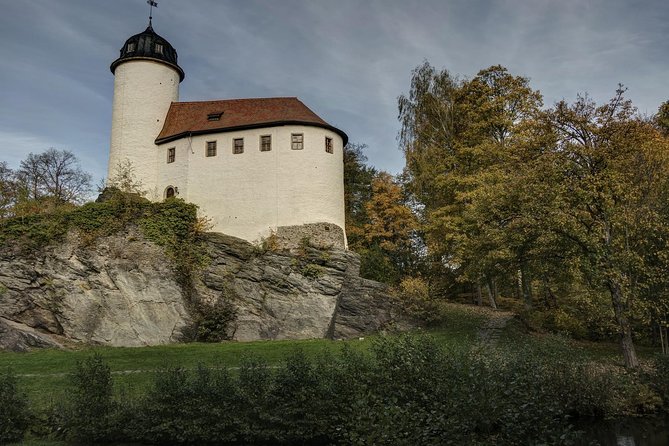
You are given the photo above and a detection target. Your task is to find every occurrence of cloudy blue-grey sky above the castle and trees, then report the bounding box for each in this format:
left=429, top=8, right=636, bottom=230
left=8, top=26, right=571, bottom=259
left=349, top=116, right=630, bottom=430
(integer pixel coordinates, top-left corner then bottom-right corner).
left=0, top=0, right=669, bottom=181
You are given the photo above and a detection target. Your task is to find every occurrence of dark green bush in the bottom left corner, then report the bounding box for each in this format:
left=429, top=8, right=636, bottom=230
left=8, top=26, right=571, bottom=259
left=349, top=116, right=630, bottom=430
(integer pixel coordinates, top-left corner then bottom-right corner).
left=0, top=371, right=30, bottom=444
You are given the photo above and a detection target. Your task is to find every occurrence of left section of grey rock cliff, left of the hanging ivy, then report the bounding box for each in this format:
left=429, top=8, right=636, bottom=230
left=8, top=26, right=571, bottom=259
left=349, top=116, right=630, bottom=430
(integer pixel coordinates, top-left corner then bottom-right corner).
left=0, top=230, right=188, bottom=346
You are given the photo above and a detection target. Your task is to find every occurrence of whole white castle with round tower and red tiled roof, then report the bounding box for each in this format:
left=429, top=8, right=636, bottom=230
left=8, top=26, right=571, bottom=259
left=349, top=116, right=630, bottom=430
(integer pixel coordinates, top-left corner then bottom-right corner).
left=108, top=22, right=347, bottom=248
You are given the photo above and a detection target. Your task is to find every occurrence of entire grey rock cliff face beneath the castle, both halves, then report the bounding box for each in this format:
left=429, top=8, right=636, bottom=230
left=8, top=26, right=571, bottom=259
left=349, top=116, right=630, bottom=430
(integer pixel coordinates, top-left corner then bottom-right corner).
left=0, top=228, right=399, bottom=350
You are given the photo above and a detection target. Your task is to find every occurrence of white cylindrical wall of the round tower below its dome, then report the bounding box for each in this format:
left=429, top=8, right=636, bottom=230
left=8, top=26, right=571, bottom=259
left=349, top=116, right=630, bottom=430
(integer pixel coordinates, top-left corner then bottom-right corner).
left=107, top=60, right=179, bottom=195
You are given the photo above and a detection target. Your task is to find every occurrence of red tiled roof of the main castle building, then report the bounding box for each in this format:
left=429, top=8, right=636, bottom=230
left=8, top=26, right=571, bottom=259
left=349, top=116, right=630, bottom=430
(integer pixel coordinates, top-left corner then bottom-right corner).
left=156, top=98, right=348, bottom=145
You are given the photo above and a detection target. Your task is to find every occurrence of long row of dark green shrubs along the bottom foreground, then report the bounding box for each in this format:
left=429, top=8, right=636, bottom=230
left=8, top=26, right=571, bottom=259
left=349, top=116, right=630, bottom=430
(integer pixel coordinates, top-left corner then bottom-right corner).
left=5, top=336, right=669, bottom=446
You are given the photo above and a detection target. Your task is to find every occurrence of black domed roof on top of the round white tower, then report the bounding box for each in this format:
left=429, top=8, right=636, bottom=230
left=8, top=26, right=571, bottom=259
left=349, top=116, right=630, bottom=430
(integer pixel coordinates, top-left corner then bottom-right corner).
left=109, top=23, right=185, bottom=82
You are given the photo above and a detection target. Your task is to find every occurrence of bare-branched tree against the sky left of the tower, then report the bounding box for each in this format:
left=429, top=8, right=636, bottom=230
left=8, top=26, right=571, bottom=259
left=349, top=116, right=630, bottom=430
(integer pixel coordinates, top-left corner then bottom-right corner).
left=16, top=148, right=91, bottom=203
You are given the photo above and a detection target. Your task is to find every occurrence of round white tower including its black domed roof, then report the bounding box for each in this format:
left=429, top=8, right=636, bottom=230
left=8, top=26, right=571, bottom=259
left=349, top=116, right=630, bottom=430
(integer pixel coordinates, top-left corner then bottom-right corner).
left=107, top=23, right=184, bottom=198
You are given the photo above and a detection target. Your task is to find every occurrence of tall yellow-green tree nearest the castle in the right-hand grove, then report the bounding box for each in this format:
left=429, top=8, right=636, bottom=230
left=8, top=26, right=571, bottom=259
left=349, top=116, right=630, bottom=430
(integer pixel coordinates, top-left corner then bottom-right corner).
left=399, top=63, right=542, bottom=301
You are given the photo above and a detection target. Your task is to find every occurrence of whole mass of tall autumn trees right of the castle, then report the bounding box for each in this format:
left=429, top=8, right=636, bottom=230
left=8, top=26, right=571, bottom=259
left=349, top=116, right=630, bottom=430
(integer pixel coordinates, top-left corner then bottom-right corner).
left=398, top=62, right=669, bottom=367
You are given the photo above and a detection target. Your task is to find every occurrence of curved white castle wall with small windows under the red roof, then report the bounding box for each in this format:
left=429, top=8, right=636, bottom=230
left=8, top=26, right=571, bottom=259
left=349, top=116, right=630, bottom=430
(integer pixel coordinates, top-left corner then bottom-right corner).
left=155, top=126, right=344, bottom=241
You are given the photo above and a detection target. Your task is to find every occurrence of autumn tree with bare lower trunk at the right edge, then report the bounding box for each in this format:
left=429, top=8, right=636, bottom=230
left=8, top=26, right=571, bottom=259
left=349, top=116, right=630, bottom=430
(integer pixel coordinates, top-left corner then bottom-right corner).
left=542, top=87, right=669, bottom=368
